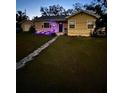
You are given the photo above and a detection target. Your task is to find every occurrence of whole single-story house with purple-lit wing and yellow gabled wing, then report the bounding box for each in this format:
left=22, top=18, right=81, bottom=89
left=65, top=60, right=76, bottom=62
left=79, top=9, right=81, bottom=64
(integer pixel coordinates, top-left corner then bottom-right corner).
left=20, top=10, right=99, bottom=36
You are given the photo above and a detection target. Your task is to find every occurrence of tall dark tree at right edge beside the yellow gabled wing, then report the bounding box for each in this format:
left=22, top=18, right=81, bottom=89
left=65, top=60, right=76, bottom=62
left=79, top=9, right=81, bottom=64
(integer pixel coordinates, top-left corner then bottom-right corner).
left=84, top=0, right=107, bottom=29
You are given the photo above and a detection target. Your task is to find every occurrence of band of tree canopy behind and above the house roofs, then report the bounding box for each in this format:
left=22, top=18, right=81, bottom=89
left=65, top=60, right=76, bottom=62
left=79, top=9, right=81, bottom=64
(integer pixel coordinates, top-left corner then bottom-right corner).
left=40, top=0, right=107, bottom=16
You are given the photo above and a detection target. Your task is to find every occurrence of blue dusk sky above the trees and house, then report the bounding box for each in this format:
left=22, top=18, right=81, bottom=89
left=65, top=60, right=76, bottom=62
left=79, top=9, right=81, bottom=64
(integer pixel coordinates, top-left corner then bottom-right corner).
left=16, top=0, right=93, bottom=18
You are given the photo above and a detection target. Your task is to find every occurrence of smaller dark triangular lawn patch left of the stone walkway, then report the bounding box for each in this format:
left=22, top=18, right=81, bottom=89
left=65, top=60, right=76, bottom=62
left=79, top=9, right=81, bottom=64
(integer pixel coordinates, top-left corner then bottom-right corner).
left=16, top=32, right=52, bottom=62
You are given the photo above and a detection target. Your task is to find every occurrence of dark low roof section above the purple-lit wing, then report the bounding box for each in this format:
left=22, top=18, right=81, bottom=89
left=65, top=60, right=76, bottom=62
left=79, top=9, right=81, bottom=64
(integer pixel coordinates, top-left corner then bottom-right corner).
left=33, top=15, right=67, bottom=21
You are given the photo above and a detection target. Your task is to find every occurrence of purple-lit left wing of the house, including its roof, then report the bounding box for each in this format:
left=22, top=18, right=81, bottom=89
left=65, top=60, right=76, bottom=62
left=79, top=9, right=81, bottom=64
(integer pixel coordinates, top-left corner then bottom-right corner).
left=33, top=16, right=67, bottom=33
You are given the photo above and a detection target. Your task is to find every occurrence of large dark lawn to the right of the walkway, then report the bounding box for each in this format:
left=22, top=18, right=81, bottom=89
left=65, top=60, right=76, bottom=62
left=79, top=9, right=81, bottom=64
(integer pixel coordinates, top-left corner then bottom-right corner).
left=17, top=36, right=107, bottom=93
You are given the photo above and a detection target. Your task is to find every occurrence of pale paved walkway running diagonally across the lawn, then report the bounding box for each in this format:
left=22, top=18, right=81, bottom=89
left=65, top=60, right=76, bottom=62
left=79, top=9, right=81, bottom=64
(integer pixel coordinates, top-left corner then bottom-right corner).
left=16, top=35, right=59, bottom=70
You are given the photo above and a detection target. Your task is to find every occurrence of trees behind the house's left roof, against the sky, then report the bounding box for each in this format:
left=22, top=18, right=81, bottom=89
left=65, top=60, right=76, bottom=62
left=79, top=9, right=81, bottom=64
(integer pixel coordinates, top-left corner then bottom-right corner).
left=40, top=3, right=83, bottom=16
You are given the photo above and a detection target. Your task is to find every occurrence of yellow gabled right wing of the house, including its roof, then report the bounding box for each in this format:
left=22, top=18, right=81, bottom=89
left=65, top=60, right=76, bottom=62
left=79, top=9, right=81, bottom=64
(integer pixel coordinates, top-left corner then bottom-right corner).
left=67, top=11, right=99, bottom=36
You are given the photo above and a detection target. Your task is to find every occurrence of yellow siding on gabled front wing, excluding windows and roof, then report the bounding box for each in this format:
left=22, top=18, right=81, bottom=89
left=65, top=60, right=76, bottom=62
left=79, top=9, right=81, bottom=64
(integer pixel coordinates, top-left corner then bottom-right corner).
left=68, top=13, right=96, bottom=36
